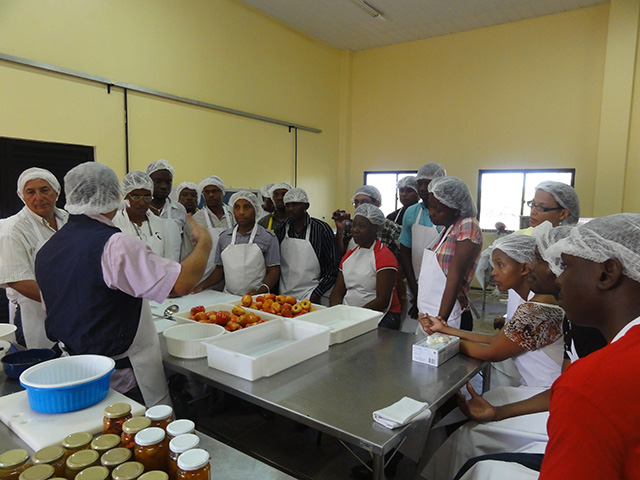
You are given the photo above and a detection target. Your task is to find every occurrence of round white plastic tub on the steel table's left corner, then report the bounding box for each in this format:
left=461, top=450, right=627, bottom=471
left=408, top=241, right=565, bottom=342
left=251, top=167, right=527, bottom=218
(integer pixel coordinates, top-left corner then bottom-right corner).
left=162, top=321, right=226, bottom=358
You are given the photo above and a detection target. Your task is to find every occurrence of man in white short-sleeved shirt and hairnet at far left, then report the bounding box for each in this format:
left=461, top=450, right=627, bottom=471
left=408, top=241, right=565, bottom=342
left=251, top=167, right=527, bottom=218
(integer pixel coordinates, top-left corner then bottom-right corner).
left=0, top=168, right=69, bottom=348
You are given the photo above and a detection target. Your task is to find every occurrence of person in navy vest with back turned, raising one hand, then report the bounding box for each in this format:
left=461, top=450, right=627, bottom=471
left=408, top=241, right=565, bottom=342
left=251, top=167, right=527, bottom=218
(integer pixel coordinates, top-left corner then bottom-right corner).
left=35, top=162, right=211, bottom=406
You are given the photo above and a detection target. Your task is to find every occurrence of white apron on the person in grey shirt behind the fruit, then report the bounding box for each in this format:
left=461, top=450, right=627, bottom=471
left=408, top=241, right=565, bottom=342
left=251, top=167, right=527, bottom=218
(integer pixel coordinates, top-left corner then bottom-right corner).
left=221, top=223, right=267, bottom=295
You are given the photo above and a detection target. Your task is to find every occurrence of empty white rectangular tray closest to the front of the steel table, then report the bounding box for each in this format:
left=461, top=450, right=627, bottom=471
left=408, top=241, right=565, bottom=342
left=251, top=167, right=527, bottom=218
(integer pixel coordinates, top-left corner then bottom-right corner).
left=203, top=318, right=330, bottom=380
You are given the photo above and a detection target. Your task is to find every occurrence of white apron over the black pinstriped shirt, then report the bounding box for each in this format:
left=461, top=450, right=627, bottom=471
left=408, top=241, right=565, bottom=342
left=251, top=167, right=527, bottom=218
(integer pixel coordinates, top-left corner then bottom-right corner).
left=280, top=223, right=320, bottom=300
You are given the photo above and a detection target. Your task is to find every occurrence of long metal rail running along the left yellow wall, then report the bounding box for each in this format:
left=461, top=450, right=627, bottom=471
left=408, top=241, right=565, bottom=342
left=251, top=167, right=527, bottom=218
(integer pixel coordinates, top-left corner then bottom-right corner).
left=0, top=53, right=322, bottom=133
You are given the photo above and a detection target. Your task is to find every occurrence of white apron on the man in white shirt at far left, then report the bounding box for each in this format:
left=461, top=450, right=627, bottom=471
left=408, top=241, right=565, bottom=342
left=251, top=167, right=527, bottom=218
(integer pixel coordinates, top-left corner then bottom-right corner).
left=7, top=215, right=54, bottom=348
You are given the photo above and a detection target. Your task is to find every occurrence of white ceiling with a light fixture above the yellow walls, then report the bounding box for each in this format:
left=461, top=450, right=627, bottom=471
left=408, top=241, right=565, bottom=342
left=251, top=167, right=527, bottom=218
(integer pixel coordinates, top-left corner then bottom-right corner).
left=240, top=0, right=608, bottom=51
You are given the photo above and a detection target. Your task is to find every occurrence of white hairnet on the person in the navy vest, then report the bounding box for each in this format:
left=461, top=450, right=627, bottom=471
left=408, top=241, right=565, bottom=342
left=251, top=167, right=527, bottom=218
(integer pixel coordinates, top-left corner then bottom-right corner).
left=64, top=162, right=122, bottom=215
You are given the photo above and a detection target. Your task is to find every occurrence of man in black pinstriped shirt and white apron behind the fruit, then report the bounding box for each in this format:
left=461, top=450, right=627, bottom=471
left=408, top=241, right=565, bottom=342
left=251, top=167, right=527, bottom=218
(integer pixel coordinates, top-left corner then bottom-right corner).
left=275, top=188, right=339, bottom=305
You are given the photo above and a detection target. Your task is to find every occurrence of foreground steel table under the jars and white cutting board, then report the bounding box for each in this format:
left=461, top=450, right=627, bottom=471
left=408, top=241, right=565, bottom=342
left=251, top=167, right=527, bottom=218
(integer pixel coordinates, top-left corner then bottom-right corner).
left=0, top=369, right=293, bottom=480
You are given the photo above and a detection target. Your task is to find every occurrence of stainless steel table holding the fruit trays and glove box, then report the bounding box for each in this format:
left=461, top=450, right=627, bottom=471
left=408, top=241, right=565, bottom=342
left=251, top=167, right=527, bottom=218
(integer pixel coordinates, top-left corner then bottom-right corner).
left=161, top=328, right=484, bottom=479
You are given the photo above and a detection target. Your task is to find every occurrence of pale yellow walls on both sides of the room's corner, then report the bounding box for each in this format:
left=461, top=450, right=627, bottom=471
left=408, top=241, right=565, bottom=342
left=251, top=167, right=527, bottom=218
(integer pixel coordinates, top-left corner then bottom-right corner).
left=0, top=0, right=640, bottom=217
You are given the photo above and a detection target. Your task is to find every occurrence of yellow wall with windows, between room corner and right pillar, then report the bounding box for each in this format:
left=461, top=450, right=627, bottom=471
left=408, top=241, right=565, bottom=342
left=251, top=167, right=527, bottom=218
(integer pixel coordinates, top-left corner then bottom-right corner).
left=349, top=4, right=608, bottom=215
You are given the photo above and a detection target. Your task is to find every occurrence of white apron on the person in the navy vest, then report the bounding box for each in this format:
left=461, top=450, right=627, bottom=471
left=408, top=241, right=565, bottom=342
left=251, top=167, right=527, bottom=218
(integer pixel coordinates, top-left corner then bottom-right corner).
left=114, top=300, right=171, bottom=407
